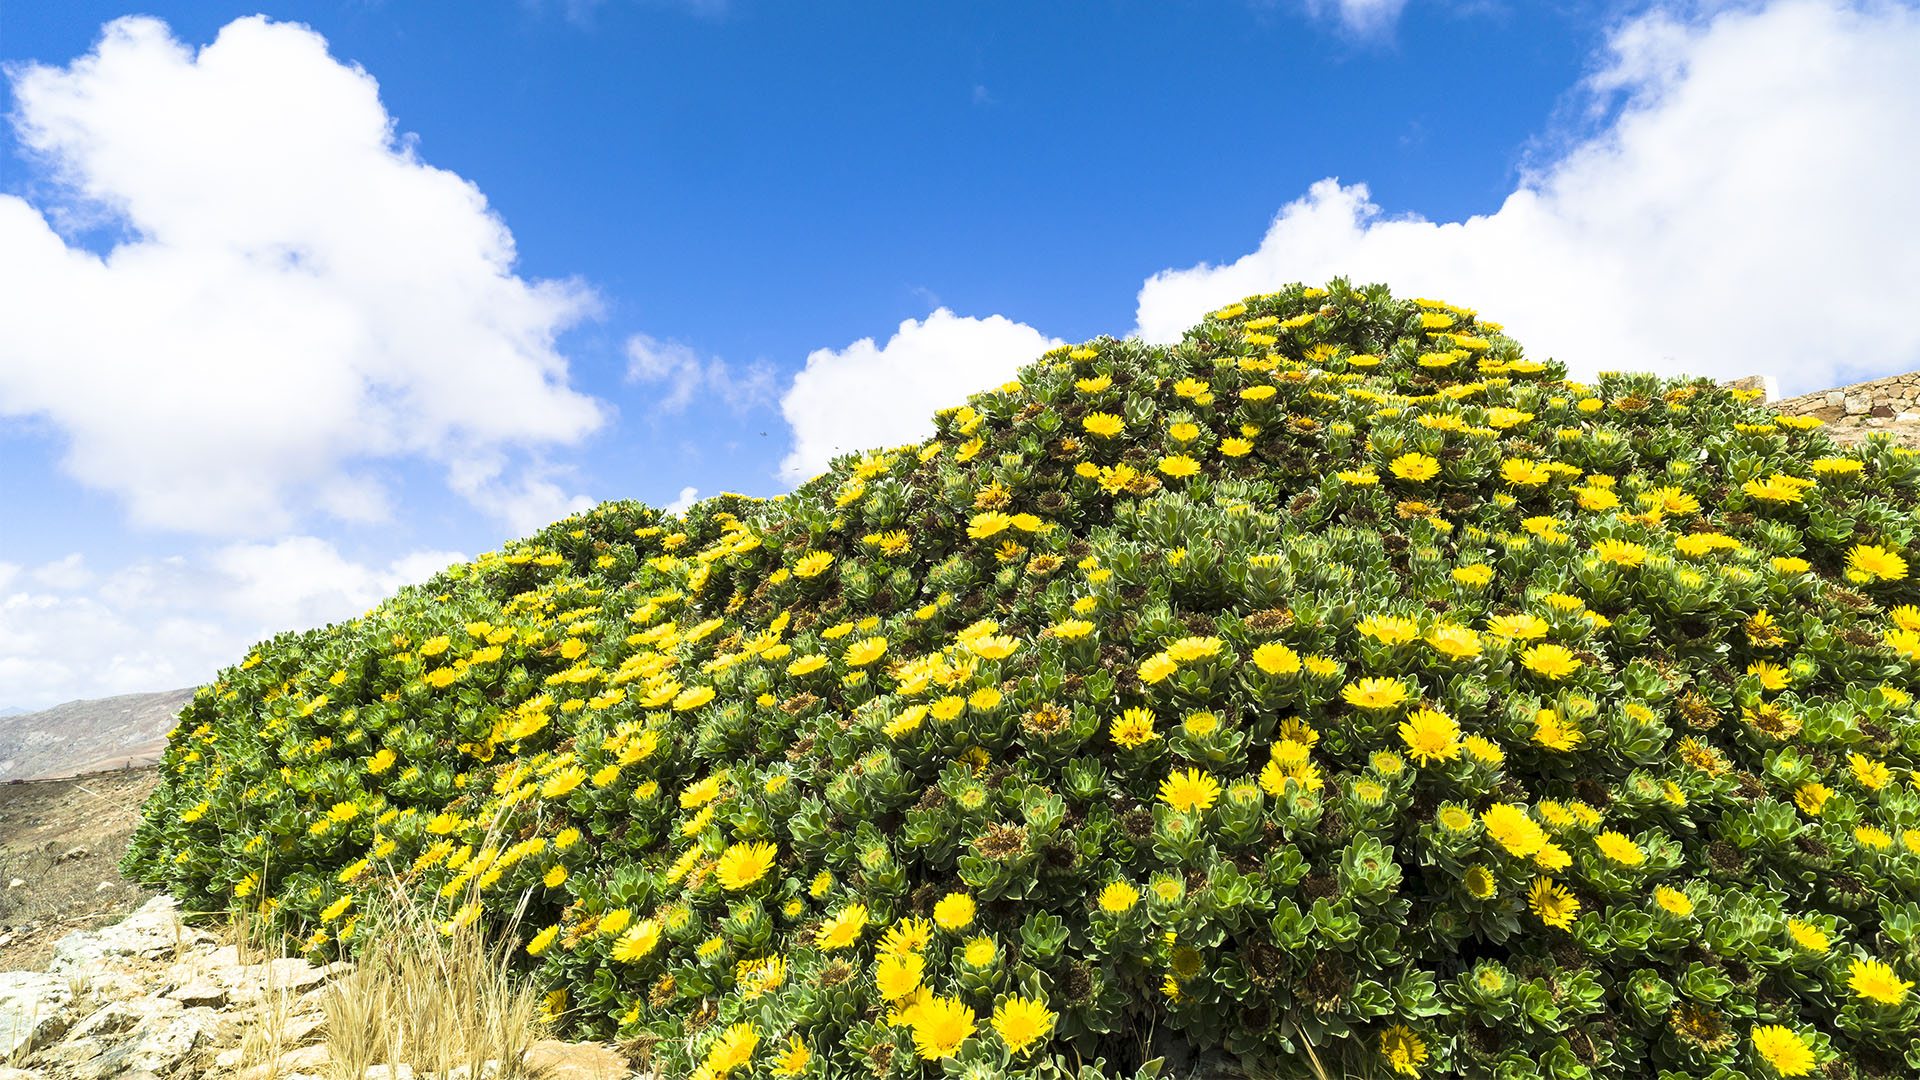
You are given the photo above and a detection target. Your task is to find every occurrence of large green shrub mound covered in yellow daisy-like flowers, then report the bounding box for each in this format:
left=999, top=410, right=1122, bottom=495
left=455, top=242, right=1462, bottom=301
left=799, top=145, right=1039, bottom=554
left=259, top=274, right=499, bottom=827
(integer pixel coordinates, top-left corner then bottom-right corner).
left=129, top=281, right=1920, bottom=1080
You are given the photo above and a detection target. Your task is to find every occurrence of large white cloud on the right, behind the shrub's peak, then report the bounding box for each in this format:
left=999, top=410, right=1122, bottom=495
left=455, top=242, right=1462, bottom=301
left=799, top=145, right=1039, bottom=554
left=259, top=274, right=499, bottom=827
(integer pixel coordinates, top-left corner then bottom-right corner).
left=1139, top=0, right=1920, bottom=394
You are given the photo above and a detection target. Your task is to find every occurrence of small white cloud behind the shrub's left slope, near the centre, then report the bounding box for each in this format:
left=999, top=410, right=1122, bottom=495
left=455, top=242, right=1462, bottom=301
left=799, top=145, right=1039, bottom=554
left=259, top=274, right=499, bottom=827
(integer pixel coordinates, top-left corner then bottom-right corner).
left=780, top=307, right=1060, bottom=482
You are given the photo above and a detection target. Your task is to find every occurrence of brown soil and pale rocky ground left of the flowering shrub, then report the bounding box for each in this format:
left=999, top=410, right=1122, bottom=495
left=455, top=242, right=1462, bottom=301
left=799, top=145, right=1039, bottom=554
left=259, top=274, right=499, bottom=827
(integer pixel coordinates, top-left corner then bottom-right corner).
left=0, top=769, right=630, bottom=1080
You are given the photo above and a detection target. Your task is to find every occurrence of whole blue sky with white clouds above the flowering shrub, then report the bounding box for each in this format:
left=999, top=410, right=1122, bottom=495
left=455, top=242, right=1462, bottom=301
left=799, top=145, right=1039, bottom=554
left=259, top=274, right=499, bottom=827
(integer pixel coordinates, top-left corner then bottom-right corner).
left=0, top=0, right=1920, bottom=705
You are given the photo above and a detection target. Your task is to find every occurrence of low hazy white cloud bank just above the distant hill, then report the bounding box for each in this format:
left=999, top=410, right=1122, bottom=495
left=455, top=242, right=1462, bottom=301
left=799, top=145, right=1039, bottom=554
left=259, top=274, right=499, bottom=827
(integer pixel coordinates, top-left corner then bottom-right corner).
left=0, top=536, right=467, bottom=707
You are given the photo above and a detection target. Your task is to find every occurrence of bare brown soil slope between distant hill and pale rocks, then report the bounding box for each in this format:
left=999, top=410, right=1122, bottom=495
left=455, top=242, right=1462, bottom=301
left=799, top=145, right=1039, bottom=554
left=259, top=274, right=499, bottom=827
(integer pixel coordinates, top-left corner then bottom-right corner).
left=0, top=767, right=159, bottom=970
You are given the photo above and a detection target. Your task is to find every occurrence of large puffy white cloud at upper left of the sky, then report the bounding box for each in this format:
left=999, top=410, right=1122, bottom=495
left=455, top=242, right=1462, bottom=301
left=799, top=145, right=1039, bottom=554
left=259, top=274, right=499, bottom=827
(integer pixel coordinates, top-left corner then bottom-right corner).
left=0, top=17, right=603, bottom=536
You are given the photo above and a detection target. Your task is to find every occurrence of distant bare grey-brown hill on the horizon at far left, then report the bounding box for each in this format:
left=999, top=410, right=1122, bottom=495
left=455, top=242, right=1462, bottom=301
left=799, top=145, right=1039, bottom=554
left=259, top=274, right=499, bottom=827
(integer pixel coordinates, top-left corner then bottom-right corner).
left=0, top=688, right=194, bottom=780
